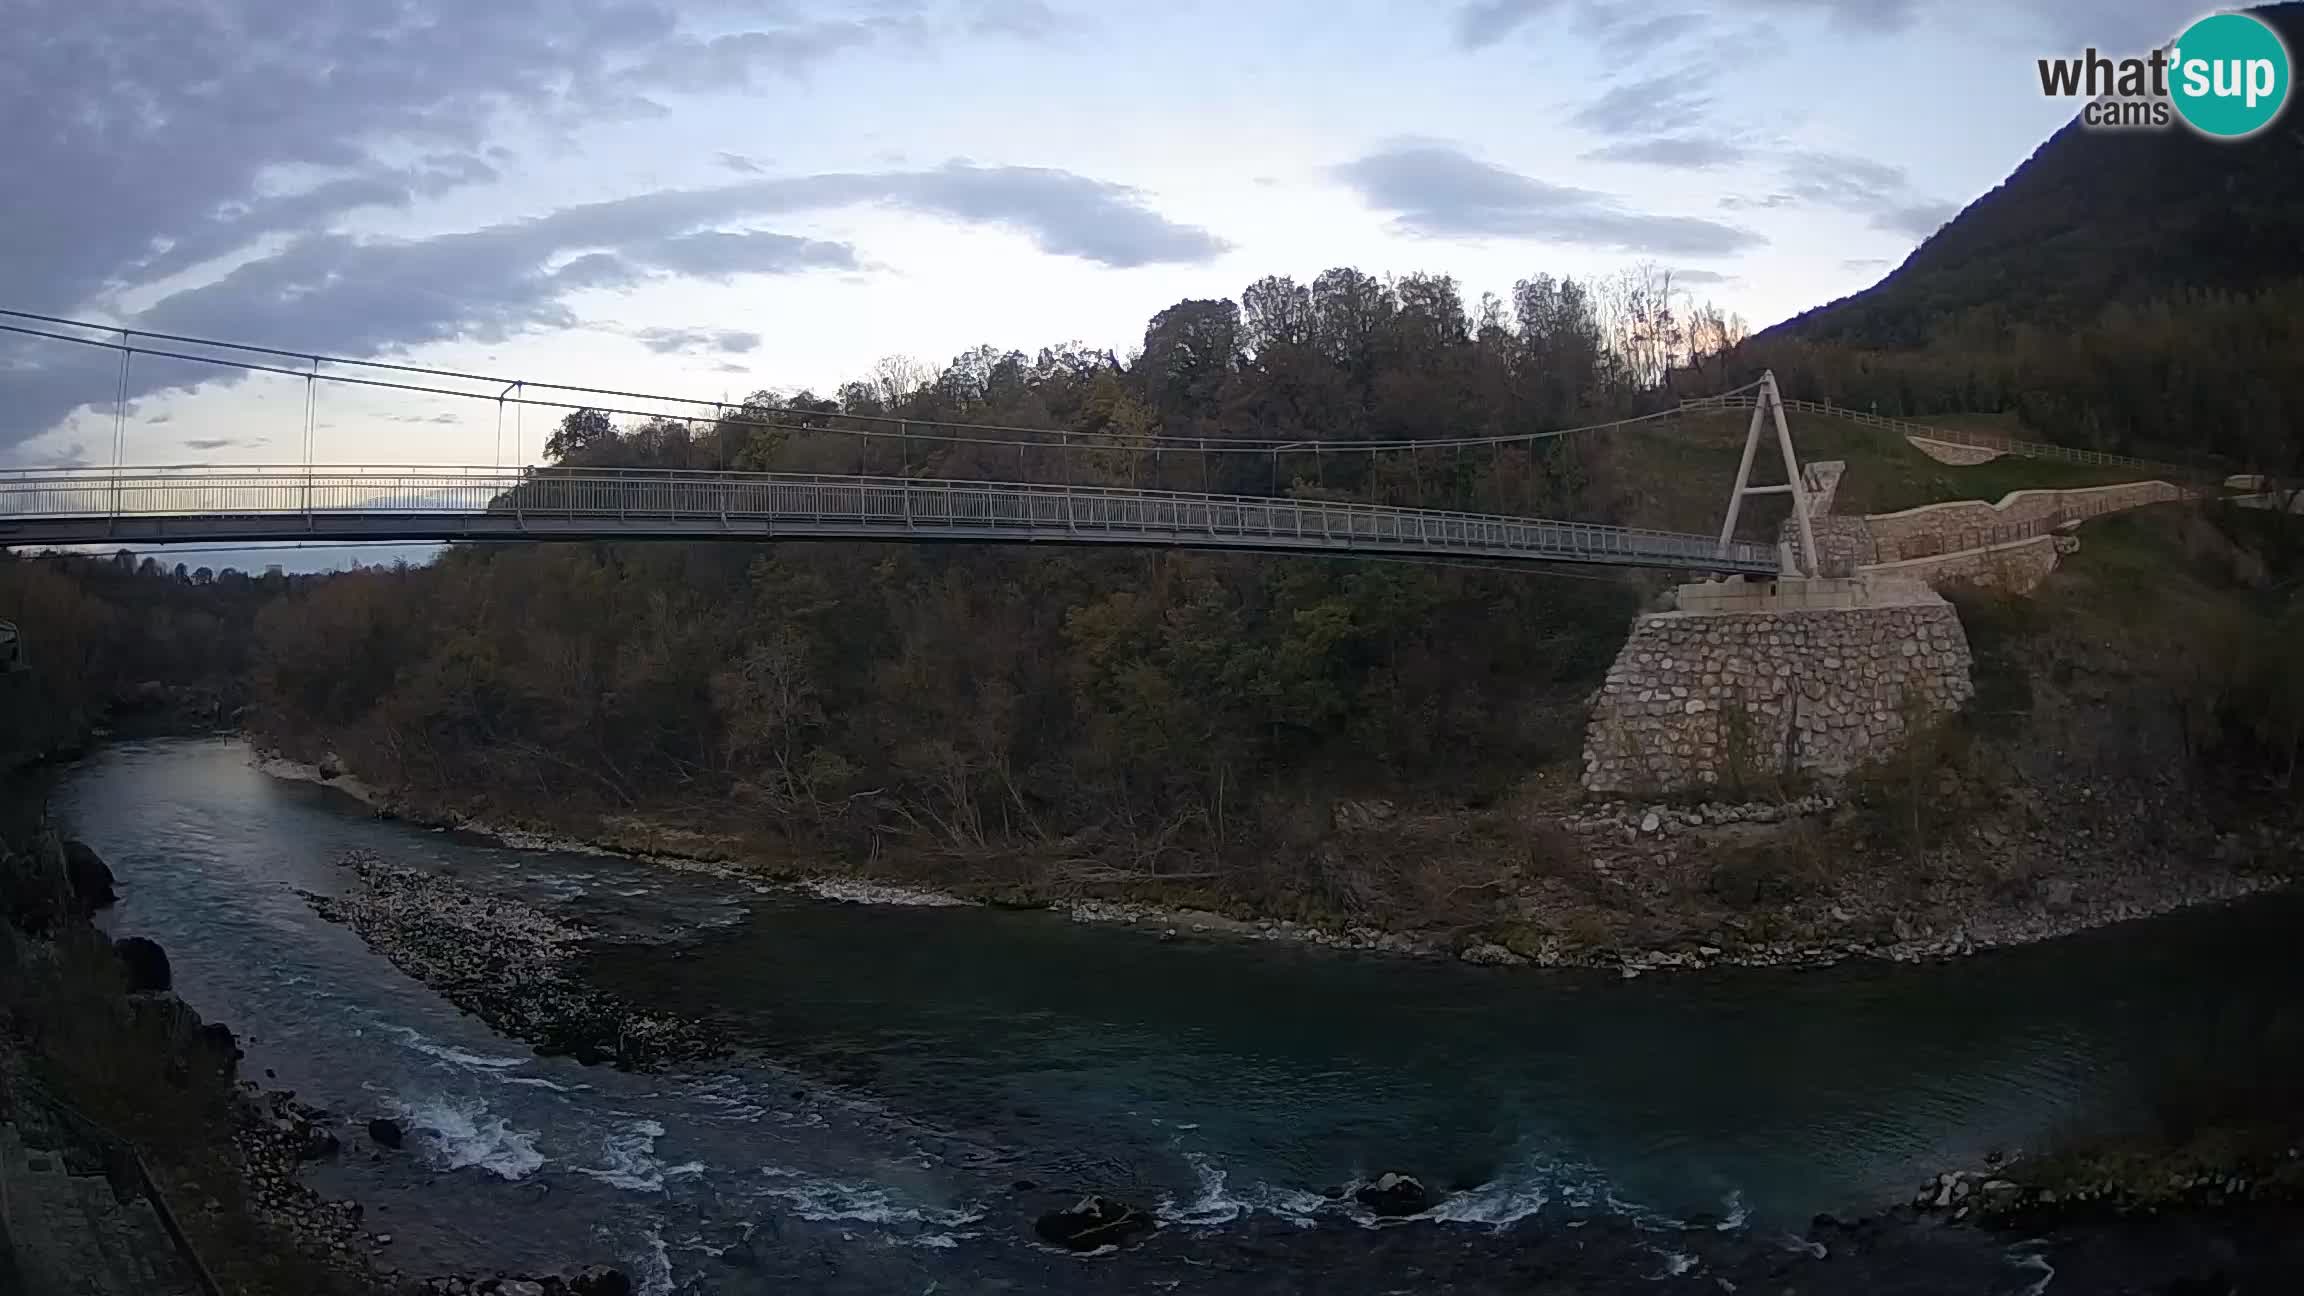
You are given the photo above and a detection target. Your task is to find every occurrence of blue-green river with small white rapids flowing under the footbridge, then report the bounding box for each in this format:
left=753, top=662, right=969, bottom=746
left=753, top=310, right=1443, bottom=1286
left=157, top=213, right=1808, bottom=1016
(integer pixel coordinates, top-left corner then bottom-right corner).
left=51, top=738, right=2304, bottom=1294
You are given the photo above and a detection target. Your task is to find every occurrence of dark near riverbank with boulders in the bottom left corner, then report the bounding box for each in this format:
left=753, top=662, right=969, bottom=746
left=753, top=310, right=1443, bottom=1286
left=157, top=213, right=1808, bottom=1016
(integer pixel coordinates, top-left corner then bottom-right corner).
left=0, top=777, right=631, bottom=1296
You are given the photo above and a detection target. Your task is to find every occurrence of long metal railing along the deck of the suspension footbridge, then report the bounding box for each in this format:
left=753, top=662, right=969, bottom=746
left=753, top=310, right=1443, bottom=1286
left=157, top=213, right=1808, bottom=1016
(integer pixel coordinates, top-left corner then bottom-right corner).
left=0, top=466, right=1779, bottom=572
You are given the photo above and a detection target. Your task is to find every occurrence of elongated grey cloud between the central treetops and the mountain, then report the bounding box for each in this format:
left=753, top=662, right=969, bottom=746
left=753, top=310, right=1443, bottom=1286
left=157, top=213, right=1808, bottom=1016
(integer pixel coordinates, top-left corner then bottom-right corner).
left=1334, top=141, right=1765, bottom=256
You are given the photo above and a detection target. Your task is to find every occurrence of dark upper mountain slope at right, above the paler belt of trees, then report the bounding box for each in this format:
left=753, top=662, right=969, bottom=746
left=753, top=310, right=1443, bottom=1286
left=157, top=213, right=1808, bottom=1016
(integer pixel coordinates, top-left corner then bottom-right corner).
left=1760, top=2, right=2304, bottom=348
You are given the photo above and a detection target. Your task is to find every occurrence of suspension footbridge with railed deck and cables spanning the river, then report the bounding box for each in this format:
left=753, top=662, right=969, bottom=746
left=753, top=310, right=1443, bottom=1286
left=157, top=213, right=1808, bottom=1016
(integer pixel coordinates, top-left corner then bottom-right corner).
left=0, top=311, right=1797, bottom=574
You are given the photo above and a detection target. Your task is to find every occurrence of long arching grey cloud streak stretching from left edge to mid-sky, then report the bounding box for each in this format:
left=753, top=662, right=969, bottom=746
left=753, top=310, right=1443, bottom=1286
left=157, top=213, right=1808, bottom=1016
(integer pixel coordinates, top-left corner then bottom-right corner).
left=0, top=161, right=1228, bottom=438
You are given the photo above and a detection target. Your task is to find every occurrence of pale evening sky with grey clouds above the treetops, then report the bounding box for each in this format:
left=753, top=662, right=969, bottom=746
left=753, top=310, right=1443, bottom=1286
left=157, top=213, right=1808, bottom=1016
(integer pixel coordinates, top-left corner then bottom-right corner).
left=0, top=0, right=2198, bottom=475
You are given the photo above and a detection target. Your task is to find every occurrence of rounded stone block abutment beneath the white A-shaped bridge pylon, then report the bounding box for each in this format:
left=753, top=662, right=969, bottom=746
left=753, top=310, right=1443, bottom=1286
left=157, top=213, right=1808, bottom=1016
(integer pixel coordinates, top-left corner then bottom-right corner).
left=1583, top=595, right=1975, bottom=796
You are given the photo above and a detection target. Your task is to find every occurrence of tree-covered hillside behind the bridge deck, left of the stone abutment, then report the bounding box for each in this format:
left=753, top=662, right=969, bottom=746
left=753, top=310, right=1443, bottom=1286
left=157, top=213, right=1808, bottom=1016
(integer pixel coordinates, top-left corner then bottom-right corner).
left=258, top=270, right=1735, bottom=908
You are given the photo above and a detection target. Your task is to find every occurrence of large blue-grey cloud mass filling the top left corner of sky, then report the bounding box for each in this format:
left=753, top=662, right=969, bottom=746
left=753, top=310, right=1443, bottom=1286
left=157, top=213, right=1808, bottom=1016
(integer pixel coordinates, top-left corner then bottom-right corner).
left=0, top=0, right=1046, bottom=445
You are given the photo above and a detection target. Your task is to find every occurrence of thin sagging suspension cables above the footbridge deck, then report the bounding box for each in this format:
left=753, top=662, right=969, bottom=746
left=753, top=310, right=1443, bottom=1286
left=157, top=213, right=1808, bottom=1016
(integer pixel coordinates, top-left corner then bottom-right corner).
left=0, top=307, right=1758, bottom=454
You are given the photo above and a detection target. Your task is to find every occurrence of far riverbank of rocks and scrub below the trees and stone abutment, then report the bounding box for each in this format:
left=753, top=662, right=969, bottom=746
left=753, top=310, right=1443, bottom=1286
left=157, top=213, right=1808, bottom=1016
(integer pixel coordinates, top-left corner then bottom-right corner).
left=258, top=737, right=2304, bottom=978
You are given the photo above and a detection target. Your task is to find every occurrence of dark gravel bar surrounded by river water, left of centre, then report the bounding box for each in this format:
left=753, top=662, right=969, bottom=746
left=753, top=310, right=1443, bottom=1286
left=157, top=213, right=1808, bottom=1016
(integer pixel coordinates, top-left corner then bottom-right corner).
left=304, top=851, right=726, bottom=1068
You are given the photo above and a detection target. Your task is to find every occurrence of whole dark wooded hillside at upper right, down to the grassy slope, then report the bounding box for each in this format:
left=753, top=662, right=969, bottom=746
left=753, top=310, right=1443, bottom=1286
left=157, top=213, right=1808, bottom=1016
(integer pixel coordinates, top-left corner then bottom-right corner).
left=1746, top=2, right=2304, bottom=473
